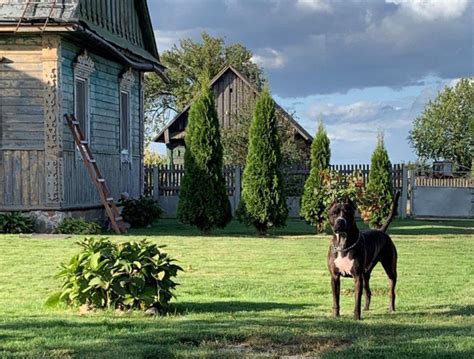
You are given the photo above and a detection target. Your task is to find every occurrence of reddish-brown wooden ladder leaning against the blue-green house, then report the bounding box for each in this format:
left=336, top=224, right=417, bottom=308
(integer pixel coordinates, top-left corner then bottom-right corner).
left=64, top=114, right=127, bottom=234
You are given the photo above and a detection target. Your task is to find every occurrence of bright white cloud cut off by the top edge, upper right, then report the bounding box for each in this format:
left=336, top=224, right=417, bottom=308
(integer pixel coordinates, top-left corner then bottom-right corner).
left=386, top=0, right=468, bottom=21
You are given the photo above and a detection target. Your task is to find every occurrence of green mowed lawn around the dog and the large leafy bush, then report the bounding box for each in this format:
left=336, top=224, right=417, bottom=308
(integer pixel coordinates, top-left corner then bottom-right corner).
left=0, top=220, right=474, bottom=358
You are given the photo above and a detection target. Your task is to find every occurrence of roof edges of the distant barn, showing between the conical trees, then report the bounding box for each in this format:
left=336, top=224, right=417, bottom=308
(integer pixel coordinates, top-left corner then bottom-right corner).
left=153, top=65, right=313, bottom=142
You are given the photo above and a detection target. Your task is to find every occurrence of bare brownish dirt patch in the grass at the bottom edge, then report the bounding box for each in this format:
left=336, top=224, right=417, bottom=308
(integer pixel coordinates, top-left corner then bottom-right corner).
left=214, top=336, right=350, bottom=358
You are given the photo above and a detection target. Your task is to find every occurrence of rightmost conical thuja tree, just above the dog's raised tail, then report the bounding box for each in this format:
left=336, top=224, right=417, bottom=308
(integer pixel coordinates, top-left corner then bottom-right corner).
left=361, top=134, right=393, bottom=228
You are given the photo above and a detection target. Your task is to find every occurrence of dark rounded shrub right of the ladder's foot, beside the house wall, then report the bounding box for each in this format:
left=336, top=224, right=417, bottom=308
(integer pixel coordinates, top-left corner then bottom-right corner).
left=120, top=197, right=163, bottom=227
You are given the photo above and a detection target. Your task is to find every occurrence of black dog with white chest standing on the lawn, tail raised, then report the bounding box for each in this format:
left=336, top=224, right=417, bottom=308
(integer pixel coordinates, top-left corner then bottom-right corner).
left=328, top=192, right=400, bottom=319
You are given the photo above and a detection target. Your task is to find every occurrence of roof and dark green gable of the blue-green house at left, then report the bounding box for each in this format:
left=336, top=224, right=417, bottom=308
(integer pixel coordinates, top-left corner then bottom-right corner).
left=0, top=0, right=163, bottom=73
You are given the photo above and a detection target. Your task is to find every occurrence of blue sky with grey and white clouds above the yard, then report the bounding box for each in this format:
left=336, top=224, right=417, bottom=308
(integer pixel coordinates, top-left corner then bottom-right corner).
left=148, top=0, right=474, bottom=164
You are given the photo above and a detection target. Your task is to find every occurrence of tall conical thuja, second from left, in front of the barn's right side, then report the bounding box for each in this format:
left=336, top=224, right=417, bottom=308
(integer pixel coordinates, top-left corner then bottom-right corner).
left=239, top=89, right=288, bottom=235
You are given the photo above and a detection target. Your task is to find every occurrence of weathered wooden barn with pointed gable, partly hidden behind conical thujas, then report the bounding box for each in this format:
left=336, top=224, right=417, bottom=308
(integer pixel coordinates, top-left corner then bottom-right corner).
left=154, top=66, right=313, bottom=164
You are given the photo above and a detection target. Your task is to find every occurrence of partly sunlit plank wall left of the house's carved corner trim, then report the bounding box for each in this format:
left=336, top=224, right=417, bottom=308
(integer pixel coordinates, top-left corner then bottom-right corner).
left=0, top=36, right=46, bottom=211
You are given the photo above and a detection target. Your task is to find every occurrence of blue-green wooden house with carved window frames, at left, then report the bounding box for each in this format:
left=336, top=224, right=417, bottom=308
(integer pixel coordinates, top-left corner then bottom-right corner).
left=0, top=0, right=164, bottom=231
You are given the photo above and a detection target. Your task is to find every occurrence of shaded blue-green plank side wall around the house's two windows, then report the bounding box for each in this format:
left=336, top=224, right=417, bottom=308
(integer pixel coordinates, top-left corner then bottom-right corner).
left=61, top=40, right=141, bottom=208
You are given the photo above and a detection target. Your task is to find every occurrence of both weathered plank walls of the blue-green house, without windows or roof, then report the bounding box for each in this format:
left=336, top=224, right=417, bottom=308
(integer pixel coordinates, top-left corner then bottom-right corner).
left=0, top=36, right=143, bottom=211
